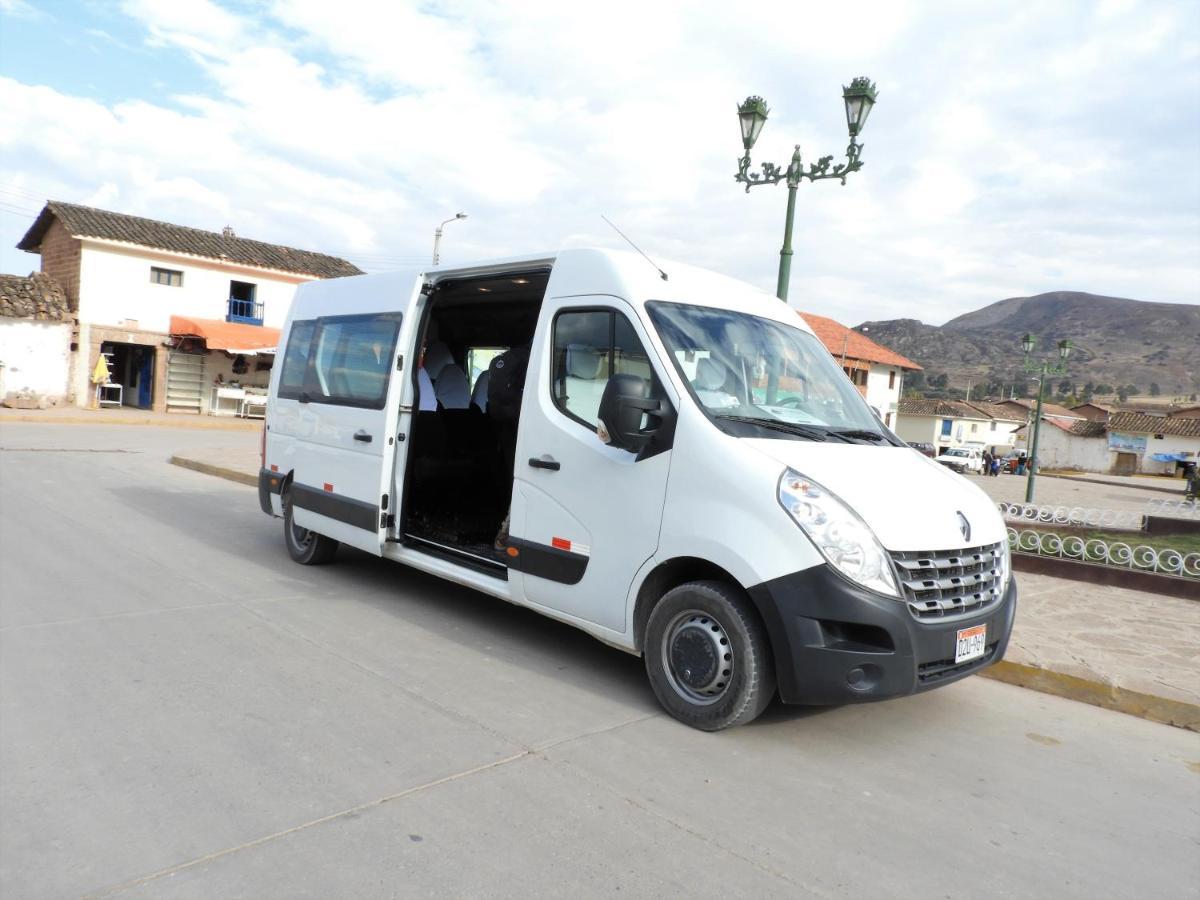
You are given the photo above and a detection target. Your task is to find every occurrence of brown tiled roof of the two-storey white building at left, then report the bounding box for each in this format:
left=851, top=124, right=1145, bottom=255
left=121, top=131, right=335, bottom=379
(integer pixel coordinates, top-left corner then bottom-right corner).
left=17, top=200, right=362, bottom=278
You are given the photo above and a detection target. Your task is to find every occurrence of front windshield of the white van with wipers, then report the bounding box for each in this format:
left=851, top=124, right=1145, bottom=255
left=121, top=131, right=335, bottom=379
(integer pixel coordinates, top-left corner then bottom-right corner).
left=647, top=301, right=894, bottom=444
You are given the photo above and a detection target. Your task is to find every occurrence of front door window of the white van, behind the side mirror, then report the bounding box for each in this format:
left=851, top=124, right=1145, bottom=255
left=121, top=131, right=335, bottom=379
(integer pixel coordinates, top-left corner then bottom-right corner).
left=551, top=310, right=654, bottom=431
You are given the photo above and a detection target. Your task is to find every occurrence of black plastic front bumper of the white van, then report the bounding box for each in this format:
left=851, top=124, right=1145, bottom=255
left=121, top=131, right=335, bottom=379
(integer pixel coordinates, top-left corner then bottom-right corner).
left=749, top=565, right=1016, bottom=706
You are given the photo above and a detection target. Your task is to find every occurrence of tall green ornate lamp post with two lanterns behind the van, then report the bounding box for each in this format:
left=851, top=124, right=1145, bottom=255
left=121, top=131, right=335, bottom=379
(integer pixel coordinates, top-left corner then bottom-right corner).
left=733, top=78, right=876, bottom=304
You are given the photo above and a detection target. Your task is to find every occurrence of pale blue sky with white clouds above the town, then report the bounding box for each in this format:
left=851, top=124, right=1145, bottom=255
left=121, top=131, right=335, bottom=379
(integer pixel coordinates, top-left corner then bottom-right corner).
left=0, top=0, right=1200, bottom=325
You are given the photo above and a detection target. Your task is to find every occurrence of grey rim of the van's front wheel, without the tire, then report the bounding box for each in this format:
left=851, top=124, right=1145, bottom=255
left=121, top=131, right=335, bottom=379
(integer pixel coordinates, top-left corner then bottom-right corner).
left=662, top=610, right=734, bottom=706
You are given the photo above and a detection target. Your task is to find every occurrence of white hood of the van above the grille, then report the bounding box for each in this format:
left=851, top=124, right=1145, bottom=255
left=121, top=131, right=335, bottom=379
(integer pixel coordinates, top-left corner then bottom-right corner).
left=742, top=438, right=1007, bottom=551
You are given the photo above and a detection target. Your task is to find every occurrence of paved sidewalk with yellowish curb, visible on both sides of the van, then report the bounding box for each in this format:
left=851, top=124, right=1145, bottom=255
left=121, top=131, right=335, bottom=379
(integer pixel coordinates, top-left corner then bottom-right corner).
left=170, top=439, right=1200, bottom=731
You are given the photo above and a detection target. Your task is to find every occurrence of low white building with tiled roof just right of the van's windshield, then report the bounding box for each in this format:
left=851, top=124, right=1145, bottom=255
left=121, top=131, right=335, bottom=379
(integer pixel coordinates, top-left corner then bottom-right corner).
left=895, top=400, right=1025, bottom=456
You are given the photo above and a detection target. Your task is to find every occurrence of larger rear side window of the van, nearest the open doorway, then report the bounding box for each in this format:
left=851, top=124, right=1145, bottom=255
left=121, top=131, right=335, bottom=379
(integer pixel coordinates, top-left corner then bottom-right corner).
left=305, top=313, right=400, bottom=409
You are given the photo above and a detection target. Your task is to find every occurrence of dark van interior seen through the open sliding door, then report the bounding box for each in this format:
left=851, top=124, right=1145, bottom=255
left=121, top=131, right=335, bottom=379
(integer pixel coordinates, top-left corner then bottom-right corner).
left=401, top=270, right=550, bottom=575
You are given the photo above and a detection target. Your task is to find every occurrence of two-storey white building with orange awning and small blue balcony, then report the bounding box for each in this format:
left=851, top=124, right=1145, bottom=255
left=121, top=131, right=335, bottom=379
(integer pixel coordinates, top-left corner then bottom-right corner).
left=17, top=200, right=361, bottom=412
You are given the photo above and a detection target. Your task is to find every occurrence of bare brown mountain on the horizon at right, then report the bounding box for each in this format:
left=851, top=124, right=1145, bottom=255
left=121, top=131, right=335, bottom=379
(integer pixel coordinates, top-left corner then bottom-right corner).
left=858, top=290, right=1200, bottom=398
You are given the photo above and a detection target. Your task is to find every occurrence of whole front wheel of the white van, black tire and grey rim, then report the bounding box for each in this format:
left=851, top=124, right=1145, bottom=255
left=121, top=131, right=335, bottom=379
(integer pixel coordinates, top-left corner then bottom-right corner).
left=644, top=581, right=775, bottom=731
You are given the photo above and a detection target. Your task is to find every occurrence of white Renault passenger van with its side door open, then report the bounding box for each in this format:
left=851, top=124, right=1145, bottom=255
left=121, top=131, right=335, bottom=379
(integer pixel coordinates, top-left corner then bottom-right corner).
left=259, top=250, right=1016, bottom=731
